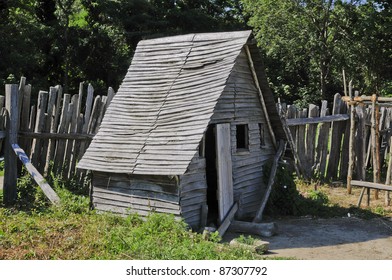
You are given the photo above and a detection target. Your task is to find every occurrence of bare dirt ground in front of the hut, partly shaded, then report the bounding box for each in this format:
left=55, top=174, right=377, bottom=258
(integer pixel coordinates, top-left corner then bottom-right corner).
left=262, top=217, right=392, bottom=260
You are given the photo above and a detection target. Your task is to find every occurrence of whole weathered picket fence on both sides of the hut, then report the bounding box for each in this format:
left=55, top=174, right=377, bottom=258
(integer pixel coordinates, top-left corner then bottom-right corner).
left=0, top=78, right=392, bottom=208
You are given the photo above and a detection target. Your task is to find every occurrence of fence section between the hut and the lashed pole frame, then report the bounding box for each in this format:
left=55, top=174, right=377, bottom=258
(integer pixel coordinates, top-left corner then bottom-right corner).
left=279, top=94, right=350, bottom=180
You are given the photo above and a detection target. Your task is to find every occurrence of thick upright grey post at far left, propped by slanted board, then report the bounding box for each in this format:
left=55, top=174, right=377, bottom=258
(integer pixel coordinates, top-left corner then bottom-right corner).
left=3, top=84, right=19, bottom=205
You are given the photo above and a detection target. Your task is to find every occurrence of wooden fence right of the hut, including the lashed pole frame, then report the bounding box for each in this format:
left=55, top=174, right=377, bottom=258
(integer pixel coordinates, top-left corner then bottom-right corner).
left=279, top=92, right=392, bottom=205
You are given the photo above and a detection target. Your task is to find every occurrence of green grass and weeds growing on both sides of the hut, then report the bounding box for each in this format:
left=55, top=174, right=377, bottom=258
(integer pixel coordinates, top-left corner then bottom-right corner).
left=0, top=166, right=390, bottom=260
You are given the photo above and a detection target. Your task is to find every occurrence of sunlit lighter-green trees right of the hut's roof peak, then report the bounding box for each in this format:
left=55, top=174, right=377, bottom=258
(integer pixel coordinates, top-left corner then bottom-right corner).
left=242, top=0, right=392, bottom=103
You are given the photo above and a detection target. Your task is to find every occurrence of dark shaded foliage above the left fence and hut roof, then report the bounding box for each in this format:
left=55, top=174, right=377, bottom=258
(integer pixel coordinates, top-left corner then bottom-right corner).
left=0, top=0, right=242, bottom=95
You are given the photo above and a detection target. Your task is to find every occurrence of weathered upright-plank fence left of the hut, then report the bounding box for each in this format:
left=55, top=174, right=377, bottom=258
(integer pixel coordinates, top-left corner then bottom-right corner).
left=0, top=77, right=115, bottom=205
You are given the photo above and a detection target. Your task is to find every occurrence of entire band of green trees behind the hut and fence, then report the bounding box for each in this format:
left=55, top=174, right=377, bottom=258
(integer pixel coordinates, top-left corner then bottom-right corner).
left=0, top=0, right=392, bottom=104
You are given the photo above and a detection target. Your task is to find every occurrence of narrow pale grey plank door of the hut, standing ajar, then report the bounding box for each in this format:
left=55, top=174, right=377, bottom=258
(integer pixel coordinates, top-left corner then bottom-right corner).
left=216, top=123, right=234, bottom=223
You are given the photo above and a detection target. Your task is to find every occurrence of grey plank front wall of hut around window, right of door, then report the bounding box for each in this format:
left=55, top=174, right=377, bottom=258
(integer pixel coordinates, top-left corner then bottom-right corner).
left=211, top=50, right=275, bottom=218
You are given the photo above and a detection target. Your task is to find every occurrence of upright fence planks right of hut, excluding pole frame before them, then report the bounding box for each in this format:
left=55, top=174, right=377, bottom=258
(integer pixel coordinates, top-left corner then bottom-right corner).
left=279, top=94, right=392, bottom=181
